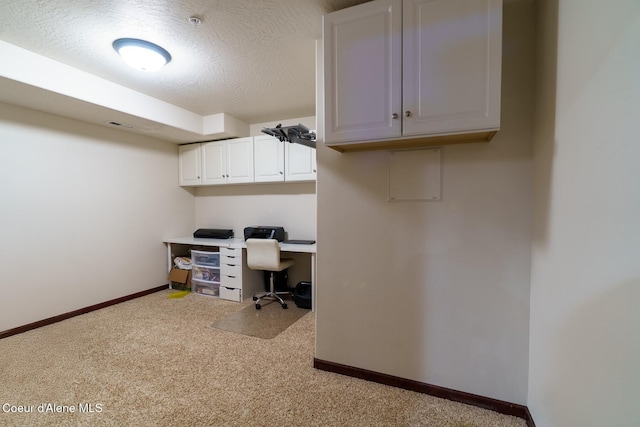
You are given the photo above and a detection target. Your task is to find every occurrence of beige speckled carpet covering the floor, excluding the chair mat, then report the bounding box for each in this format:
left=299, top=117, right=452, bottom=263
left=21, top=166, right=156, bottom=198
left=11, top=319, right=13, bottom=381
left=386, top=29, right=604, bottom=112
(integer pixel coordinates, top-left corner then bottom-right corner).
left=0, top=290, right=526, bottom=427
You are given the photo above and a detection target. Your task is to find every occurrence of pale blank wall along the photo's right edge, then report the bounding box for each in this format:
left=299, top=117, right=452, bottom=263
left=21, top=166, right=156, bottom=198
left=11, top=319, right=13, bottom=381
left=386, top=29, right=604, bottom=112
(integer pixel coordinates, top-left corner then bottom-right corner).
left=528, top=0, right=640, bottom=427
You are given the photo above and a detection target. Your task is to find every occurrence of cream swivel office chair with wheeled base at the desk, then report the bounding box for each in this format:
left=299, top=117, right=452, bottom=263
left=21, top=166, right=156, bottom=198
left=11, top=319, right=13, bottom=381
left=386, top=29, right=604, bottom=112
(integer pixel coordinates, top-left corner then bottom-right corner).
left=246, top=239, right=295, bottom=310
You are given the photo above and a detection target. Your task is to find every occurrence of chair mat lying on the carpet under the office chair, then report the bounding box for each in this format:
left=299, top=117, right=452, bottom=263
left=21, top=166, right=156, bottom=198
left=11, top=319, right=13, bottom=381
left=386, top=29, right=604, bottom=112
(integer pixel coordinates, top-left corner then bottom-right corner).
left=211, top=301, right=309, bottom=339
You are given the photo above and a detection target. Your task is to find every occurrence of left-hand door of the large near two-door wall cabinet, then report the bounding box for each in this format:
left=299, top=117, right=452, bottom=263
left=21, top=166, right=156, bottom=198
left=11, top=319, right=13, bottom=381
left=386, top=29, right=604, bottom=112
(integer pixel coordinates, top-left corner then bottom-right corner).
left=323, top=0, right=402, bottom=144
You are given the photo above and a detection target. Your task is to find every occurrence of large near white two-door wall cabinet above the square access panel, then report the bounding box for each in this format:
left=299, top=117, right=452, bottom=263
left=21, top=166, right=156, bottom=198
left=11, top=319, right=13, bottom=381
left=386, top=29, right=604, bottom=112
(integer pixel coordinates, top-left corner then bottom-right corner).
left=323, top=0, right=502, bottom=150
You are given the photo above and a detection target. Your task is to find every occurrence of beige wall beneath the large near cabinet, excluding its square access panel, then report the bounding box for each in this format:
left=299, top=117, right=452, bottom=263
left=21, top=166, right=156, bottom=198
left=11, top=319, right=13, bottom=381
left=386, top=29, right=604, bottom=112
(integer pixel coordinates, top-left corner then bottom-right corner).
left=316, top=1, right=535, bottom=404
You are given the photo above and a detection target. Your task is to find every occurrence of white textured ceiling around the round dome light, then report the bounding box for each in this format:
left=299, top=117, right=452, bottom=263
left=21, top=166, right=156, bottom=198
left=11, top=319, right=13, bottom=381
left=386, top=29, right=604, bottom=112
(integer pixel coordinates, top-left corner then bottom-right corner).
left=0, top=0, right=367, bottom=123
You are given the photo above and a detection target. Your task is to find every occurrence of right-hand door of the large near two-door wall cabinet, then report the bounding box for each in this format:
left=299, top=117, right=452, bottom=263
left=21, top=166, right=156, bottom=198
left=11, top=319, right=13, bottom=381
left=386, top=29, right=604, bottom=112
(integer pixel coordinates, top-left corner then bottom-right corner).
left=402, top=0, right=502, bottom=135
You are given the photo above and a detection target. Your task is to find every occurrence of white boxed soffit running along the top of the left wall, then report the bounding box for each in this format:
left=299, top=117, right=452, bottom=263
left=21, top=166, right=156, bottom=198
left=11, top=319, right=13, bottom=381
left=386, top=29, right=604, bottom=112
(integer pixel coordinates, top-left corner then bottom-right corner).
left=0, top=40, right=268, bottom=143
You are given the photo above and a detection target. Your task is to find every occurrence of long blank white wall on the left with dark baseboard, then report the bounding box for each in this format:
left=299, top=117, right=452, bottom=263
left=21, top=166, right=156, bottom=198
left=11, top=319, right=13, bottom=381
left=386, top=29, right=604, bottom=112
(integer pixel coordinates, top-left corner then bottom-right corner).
left=0, top=104, right=195, bottom=331
